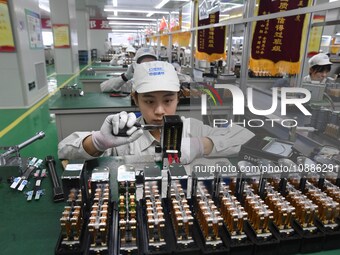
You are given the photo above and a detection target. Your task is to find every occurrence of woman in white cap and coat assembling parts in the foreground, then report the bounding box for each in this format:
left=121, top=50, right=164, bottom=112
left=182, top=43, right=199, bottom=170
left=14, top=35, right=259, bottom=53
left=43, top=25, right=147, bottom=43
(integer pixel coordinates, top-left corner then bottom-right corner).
left=58, top=61, right=254, bottom=164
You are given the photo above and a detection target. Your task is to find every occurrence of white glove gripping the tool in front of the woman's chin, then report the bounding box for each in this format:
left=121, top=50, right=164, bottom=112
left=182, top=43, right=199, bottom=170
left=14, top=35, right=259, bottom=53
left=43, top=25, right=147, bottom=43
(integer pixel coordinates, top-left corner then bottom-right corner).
left=92, top=112, right=143, bottom=151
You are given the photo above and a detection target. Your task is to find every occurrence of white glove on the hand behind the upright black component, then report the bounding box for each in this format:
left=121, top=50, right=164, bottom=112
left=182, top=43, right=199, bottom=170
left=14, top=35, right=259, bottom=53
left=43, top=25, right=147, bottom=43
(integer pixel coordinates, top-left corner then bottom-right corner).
left=181, top=137, right=204, bottom=164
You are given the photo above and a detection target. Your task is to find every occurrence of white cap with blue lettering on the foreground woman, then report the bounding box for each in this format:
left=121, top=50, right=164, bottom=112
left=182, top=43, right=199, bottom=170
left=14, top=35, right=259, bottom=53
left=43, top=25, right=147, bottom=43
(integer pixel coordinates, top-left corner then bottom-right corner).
left=132, top=61, right=180, bottom=93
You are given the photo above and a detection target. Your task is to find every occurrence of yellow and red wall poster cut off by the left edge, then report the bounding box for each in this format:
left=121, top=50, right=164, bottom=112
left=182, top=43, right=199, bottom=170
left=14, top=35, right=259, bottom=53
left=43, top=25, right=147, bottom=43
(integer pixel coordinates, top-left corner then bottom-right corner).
left=0, top=0, right=15, bottom=52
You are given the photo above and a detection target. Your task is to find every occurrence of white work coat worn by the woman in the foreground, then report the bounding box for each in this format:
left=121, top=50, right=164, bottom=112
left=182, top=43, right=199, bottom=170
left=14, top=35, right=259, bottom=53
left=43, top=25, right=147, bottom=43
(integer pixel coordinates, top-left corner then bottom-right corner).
left=58, top=117, right=254, bottom=159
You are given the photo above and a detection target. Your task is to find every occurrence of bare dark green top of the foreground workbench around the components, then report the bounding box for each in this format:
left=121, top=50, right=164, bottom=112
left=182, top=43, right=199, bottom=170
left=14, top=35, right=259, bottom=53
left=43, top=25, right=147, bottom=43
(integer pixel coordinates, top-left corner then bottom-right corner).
left=0, top=156, right=340, bottom=255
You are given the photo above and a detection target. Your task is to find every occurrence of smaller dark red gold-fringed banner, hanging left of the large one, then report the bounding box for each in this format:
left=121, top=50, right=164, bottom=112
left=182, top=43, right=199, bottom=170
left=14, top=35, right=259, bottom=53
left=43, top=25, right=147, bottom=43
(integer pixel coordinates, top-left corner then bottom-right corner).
left=195, top=12, right=226, bottom=62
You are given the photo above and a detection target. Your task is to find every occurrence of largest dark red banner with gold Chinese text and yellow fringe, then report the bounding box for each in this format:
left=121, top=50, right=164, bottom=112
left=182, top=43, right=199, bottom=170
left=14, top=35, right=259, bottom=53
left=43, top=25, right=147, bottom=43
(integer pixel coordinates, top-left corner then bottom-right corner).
left=249, top=0, right=310, bottom=75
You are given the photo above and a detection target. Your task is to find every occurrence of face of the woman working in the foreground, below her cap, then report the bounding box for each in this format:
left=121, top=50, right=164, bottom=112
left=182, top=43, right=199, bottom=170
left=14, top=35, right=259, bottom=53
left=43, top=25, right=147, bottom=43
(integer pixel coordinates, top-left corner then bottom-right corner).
left=134, top=91, right=178, bottom=124
